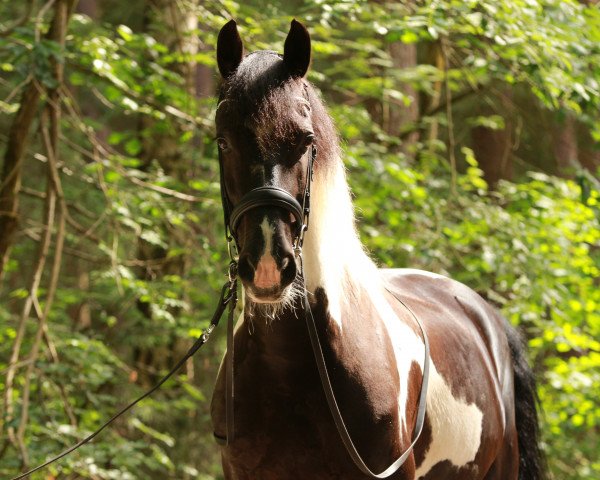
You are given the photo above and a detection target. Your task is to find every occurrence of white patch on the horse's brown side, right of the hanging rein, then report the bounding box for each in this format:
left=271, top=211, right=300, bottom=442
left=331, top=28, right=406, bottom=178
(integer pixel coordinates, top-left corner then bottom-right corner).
left=415, top=362, right=483, bottom=478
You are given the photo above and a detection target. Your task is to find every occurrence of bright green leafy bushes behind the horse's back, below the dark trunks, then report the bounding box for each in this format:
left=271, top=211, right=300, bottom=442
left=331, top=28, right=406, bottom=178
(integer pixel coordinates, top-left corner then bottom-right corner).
left=351, top=137, right=600, bottom=478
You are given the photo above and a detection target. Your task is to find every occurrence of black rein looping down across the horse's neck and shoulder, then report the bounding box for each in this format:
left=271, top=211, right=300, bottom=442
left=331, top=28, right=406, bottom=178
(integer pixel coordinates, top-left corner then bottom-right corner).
left=304, top=272, right=429, bottom=478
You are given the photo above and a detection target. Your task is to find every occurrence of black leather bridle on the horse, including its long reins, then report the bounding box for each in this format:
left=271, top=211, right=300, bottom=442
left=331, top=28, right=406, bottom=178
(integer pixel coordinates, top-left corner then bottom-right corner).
left=11, top=89, right=429, bottom=480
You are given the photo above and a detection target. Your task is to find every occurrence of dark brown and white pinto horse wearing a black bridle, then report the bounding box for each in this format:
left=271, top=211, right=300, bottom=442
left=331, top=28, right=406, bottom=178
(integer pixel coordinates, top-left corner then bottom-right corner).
left=211, top=20, right=544, bottom=480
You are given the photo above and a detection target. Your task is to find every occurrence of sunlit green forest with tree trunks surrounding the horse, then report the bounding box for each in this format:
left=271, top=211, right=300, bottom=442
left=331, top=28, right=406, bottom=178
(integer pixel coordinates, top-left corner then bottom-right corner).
left=0, top=0, right=600, bottom=480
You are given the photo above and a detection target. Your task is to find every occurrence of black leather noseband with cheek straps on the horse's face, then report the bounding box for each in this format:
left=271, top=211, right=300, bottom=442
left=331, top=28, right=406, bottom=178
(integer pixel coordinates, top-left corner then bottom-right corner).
left=219, top=143, right=317, bottom=260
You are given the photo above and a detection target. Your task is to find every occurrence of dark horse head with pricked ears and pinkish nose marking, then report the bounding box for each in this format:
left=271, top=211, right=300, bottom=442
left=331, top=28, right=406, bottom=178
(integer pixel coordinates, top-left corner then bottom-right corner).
left=216, top=20, right=316, bottom=305
